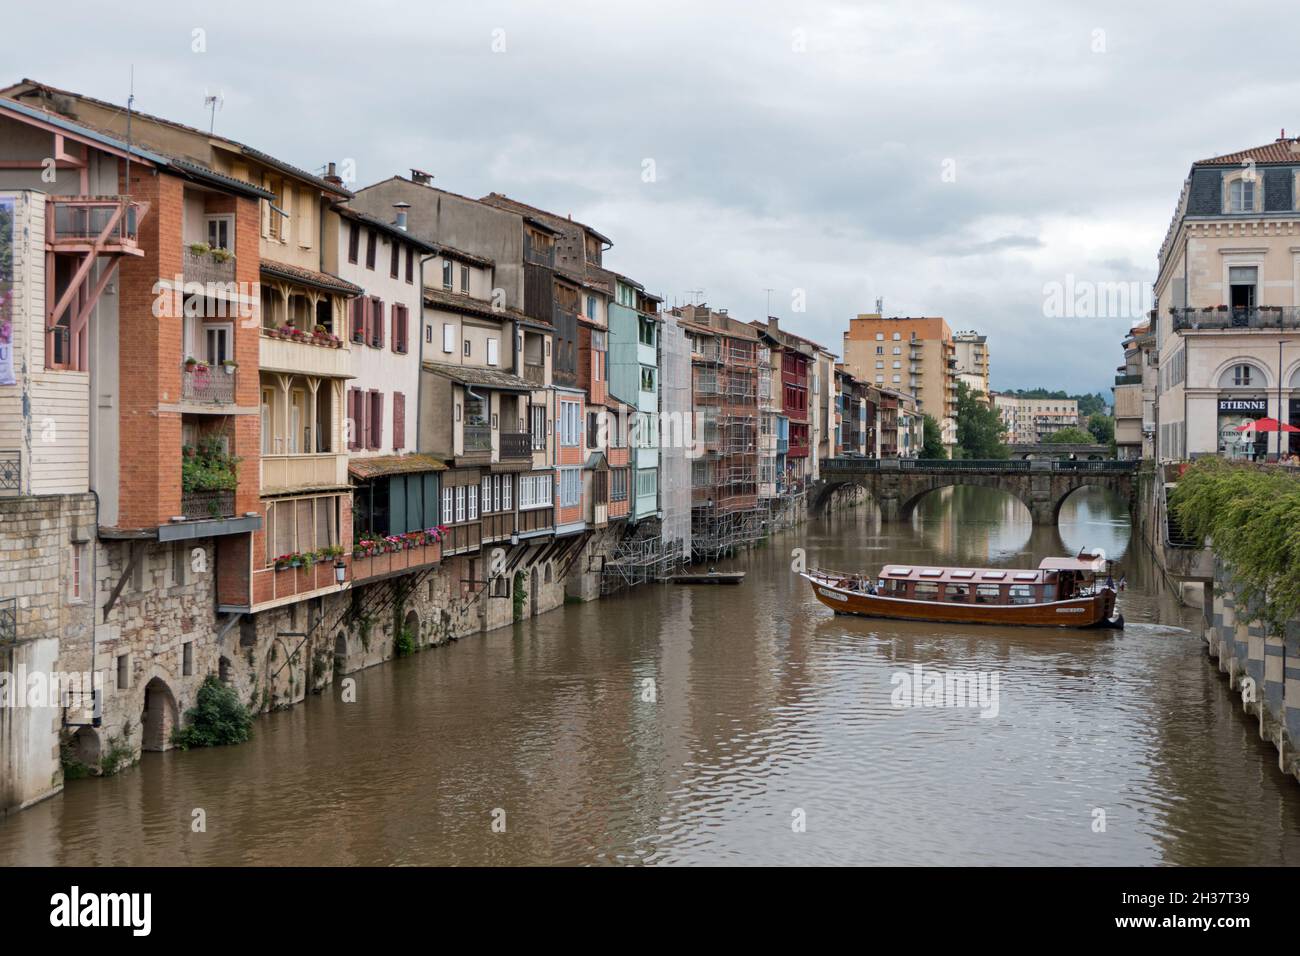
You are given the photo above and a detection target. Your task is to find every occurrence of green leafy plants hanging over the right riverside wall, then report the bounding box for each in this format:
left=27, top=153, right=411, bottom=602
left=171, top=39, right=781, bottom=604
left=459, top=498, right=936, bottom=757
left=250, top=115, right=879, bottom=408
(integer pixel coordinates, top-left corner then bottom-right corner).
left=1169, top=458, right=1300, bottom=633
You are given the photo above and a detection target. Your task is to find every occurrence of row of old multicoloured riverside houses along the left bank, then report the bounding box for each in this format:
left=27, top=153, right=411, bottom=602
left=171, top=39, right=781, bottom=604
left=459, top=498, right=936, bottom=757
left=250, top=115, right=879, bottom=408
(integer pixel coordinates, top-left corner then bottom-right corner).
left=0, top=81, right=920, bottom=808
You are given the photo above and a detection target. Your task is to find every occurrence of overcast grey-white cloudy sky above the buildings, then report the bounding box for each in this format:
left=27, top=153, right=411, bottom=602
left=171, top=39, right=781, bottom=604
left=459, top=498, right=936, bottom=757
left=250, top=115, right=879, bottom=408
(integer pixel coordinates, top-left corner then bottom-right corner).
left=5, top=0, right=1300, bottom=395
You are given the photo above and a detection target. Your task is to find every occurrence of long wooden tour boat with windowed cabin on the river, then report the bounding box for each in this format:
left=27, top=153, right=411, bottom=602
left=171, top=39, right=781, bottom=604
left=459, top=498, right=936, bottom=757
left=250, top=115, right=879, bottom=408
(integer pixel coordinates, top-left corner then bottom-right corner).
left=802, top=551, right=1125, bottom=628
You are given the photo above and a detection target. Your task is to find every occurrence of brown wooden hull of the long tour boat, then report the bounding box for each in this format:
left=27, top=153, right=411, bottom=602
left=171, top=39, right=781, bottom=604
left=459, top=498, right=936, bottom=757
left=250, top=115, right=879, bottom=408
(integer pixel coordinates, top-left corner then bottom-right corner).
left=803, top=575, right=1123, bottom=627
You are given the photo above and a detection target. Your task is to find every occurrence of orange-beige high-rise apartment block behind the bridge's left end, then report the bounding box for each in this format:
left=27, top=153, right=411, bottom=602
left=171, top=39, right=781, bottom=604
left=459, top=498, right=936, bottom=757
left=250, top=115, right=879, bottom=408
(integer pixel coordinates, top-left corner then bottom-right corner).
left=844, top=312, right=957, bottom=450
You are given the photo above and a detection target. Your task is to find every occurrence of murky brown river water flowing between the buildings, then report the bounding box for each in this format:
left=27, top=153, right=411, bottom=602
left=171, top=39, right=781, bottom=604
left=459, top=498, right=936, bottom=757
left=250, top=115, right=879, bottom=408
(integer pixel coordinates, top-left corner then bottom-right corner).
left=0, top=488, right=1300, bottom=866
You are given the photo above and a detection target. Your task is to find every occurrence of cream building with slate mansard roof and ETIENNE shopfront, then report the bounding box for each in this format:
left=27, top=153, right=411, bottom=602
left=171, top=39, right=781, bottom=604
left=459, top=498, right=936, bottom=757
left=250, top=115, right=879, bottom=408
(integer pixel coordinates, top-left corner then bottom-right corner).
left=1153, top=137, right=1300, bottom=460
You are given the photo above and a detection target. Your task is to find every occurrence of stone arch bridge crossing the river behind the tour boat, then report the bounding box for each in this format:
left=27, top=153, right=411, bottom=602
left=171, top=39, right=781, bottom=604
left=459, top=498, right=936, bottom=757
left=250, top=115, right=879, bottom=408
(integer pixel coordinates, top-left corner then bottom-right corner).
left=809, top=458, right=1138, bottom=525
